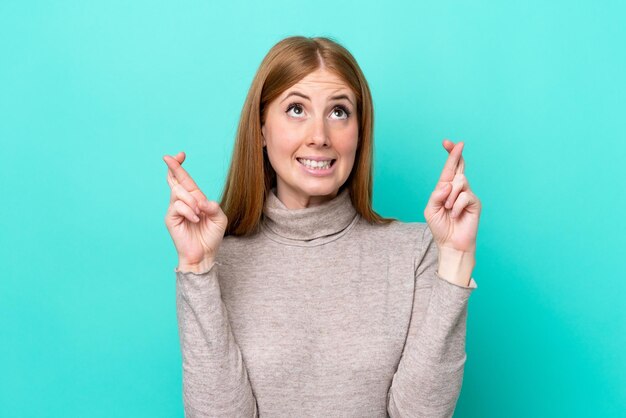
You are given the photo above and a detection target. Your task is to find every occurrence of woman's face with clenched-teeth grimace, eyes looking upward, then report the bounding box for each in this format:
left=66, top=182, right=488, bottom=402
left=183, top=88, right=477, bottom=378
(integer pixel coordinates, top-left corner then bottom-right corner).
left=261, top=69, right=359, bottom=209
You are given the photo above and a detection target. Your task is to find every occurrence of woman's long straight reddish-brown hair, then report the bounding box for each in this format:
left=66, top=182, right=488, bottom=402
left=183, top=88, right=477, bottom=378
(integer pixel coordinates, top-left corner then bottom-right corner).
left=220, top=36, right=395, bottom=235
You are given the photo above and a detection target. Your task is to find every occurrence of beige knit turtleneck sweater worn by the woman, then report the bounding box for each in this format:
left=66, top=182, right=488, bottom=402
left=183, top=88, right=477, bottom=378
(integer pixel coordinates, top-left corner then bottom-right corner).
left=175, top=189, right=477, bottom=417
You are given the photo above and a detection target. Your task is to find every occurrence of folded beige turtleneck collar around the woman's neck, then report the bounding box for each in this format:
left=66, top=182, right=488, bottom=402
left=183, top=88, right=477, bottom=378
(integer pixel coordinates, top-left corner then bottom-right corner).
left=262, top=187, right=358, bottom=246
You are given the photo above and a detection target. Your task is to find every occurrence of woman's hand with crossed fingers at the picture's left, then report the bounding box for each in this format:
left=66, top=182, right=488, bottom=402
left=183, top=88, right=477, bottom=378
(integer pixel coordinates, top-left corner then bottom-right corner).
left=163, top=152, right=228, bottom=271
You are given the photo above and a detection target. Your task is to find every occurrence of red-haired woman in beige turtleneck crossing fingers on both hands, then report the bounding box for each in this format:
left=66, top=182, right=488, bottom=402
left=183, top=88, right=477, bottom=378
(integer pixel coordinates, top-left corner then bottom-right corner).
left=163, top=37, right=481, bottom=417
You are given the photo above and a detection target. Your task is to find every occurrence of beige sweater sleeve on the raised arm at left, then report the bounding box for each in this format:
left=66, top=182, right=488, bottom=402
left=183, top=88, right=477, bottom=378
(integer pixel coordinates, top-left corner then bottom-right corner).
left=174, top=262, right=258, bottom=418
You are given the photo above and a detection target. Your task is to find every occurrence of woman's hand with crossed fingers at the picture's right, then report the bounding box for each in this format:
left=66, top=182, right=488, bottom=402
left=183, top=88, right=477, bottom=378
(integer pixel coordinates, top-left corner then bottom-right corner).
left=424, top=140, right=481, bottom=262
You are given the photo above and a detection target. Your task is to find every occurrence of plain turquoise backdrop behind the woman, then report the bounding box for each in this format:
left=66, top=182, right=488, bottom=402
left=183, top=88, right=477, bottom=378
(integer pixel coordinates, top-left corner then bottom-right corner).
left=0, top=0, right=626, bottom=417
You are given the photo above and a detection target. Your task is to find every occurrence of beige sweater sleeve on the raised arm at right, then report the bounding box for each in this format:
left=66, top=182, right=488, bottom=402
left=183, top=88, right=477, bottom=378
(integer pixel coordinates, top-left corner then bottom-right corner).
left=387, top=226, right=478, bottom=418
